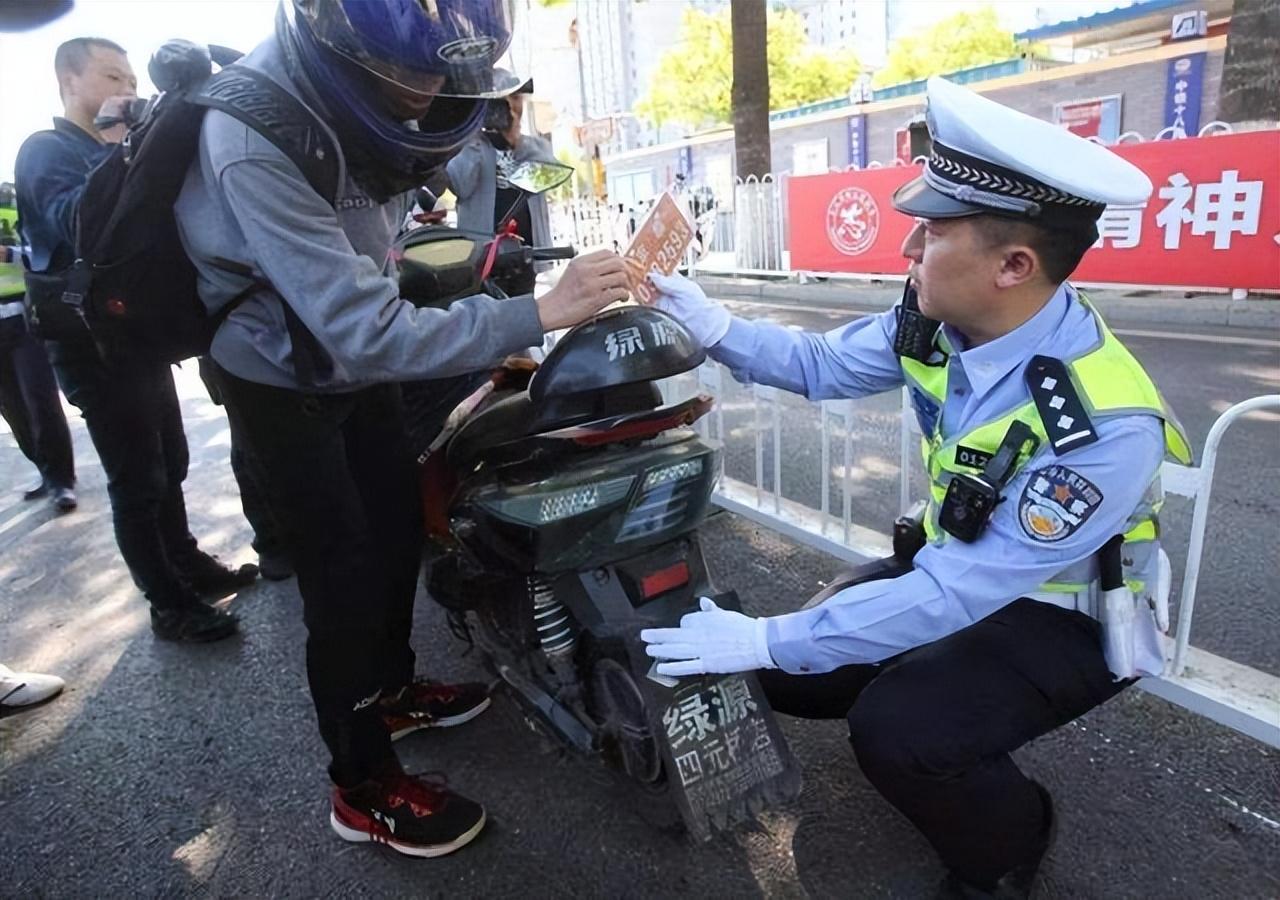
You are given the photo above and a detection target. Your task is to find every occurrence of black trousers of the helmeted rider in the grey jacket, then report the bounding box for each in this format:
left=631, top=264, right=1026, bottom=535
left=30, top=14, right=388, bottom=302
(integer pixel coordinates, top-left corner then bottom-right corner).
left=219, top=370, right=422, bottom=787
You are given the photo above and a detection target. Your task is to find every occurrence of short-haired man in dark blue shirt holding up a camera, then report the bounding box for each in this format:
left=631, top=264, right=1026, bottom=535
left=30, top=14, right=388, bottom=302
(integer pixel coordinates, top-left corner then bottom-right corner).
left=15, top=38, right=257, bottom=641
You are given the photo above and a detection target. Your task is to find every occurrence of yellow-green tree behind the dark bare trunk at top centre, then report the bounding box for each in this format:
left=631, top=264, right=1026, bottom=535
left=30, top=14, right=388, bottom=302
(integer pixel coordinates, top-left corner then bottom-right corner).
left=635, top=6, right=859, bottom=128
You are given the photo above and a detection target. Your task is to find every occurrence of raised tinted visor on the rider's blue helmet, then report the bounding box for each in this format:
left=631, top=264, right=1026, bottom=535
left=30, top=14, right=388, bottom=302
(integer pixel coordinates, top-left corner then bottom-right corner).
left=293, top=0, right=520, bottom=99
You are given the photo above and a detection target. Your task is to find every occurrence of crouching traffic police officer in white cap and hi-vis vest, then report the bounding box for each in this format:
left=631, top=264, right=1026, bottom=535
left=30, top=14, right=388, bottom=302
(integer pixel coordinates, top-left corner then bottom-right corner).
left=641, top=78, right=1190, bottom=896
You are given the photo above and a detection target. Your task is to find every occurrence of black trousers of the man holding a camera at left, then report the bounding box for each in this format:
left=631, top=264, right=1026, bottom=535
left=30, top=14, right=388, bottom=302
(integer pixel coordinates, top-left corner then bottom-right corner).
left=47, top=341, right=198, bottom=608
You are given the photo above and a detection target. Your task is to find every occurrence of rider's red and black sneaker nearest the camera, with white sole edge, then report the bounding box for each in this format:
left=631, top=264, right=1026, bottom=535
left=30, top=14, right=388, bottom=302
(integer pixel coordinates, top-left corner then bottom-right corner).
left=329, top=772, right=485, bottom=856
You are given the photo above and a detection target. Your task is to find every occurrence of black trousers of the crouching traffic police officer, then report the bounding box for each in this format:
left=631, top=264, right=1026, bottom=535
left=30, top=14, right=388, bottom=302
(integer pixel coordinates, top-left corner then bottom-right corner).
left=759, top=599, right=1125, bottom=886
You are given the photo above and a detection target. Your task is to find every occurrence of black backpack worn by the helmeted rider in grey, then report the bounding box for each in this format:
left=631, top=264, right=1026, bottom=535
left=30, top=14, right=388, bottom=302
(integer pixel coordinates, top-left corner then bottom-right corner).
left=28, top=41, right=338, bottom=368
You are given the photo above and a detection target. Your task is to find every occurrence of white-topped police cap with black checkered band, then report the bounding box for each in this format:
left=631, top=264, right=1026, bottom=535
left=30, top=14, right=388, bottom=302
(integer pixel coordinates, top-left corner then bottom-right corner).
left=893, top=77, right=1151, bottom=225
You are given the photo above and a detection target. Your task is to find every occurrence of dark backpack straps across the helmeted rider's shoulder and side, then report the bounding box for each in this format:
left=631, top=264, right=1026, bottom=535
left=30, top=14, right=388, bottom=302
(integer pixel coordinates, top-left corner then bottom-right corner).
left=191, top=65, right=339, bottom=385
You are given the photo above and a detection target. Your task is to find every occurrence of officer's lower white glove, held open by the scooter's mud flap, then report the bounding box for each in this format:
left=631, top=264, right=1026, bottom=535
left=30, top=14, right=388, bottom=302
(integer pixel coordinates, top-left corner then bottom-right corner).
left=640, top=597, right=778, bottom=675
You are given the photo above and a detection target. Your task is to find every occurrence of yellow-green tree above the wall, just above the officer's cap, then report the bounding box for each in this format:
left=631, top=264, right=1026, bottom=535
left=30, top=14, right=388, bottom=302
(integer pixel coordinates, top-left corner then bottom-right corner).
left=874, top=6, right=1020, bottom=86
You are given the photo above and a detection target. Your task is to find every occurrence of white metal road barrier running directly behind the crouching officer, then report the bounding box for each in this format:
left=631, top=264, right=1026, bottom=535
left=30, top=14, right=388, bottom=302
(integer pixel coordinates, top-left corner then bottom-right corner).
left=663, top=361, right=1280, bottom=748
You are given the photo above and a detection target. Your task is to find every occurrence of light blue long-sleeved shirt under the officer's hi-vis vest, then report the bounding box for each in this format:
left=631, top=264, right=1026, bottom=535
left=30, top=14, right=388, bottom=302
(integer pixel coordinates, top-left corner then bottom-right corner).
left=710, top=284, right=1165, bottom=673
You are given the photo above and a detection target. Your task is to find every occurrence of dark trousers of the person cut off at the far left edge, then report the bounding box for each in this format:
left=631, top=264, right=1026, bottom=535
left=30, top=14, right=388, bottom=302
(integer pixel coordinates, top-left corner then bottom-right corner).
left=0, top=311, right=76, bottom=488
